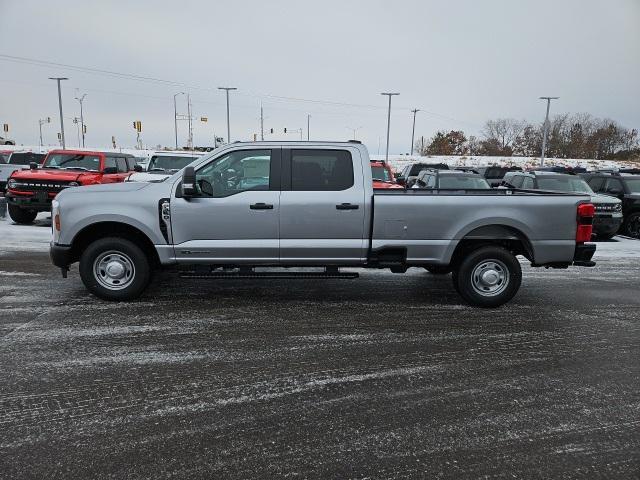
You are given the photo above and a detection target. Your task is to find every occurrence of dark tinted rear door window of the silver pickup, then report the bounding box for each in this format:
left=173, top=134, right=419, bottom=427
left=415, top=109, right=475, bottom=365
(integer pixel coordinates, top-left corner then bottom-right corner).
left=291, top=150, right=353, bottom=191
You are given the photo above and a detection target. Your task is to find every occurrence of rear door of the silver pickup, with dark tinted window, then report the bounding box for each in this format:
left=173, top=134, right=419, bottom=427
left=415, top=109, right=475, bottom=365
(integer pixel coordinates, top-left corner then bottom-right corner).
left=280, top=147, right=369, bottom=265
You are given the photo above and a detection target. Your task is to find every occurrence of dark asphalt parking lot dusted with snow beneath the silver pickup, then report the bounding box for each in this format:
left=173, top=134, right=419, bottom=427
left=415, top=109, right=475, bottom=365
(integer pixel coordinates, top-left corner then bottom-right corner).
left=0, top=240, right=640, bottom=479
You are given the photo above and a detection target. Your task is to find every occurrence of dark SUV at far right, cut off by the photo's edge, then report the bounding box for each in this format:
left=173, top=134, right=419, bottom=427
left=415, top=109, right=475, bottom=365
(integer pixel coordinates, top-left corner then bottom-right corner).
left=582, top=172, right=640, bottom=238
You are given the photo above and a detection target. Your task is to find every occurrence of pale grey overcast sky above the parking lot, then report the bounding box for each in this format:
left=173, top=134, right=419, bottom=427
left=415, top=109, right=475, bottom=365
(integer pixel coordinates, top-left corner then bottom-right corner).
left=0, top=0, right=640, bottom=153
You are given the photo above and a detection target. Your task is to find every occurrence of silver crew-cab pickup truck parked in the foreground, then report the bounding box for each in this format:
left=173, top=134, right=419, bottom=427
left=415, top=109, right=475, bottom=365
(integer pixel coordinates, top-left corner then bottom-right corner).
left=50, top=142, right=595, bottom=307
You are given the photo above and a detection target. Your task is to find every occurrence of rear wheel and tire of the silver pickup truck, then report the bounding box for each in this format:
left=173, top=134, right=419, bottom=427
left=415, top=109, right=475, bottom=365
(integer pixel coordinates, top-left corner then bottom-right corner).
left=453, top=246, right=522, bottom=308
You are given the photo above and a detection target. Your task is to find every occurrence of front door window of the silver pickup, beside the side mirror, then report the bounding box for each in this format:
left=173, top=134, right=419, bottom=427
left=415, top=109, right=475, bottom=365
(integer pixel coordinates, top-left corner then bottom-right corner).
left=196, top=150, right=271, bottom=198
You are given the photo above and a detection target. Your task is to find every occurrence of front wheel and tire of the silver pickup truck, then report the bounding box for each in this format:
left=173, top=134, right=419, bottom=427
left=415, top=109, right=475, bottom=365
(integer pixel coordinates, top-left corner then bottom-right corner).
left=79, top=237, right=151, bottom=301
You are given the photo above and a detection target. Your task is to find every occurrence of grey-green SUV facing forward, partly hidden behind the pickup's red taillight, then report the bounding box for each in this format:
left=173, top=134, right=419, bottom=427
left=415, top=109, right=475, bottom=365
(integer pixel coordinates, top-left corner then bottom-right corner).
left=503, top=171, right=622, bottom=240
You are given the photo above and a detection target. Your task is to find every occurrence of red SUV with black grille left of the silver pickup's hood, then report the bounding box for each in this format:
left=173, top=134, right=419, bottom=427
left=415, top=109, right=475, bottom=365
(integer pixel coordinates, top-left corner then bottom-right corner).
left=6, top=150, right=136, bottom=223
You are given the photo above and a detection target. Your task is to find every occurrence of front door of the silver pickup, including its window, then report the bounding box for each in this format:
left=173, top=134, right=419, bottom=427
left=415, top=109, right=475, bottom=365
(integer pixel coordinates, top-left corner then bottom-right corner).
left=171, top=148, right=280, bottom=265
